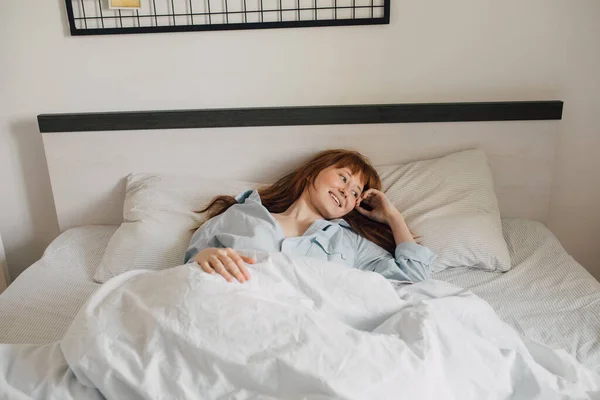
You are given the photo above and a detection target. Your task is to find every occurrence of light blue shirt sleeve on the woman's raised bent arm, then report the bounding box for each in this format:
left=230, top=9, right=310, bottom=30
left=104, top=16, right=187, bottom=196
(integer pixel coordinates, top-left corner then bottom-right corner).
left=356, top=236, right=437, bottom=282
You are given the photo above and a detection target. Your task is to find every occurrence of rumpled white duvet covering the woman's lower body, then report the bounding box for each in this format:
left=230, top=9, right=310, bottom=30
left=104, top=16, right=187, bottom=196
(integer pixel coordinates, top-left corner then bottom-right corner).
left=0, top=253, right=600, bottom=400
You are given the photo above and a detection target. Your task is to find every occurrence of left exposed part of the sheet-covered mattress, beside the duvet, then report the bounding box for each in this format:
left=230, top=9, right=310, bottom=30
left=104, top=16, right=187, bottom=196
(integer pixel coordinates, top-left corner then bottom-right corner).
left=0, top=226, right=117, bottom=344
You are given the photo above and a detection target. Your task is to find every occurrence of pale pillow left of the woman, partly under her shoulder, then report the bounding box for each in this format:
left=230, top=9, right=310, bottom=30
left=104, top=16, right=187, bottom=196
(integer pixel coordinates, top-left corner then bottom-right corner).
left=94, top=174, right=260, bottom=283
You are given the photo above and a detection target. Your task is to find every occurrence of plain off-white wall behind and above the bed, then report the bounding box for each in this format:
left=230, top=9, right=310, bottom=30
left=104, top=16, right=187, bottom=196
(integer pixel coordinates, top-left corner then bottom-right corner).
left=0, top=0, right=600, bottom=282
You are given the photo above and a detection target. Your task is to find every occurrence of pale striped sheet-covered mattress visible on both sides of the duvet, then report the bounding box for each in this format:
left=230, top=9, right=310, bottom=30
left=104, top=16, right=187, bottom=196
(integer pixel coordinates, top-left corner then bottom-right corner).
left=0, top=218, right=600, bottom=372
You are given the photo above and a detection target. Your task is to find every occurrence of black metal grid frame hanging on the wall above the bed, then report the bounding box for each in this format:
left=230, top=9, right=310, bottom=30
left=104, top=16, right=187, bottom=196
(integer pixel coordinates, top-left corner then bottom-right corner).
left=66, top=0, right=391, bottom=36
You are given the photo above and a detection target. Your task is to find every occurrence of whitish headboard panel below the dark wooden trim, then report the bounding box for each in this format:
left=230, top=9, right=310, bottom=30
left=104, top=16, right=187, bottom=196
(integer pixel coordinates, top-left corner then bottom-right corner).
left=43, top=121, right=560, bottom=231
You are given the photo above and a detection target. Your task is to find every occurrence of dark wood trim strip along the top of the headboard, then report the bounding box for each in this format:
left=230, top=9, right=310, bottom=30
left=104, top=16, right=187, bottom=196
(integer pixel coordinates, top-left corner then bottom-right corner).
left=38, top=100, right=563, bottom=133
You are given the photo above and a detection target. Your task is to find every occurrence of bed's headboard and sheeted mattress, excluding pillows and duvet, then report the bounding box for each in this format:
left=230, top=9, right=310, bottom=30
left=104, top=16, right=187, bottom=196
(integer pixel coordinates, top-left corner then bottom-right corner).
left=0, top=102, right=600, bottom=396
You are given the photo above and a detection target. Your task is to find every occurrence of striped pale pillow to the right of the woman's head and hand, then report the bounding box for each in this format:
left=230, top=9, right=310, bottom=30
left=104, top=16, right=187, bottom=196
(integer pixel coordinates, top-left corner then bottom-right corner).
left=377, top=150, right=511, bottom=271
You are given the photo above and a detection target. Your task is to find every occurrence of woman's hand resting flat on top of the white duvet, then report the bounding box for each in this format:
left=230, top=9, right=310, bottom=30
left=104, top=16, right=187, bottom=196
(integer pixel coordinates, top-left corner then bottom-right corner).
left=194, top=248, right=255, bottom=283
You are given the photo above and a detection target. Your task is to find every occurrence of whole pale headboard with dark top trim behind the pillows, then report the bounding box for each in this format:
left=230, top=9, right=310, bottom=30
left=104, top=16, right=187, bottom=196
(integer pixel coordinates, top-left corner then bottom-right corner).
left=38, top=101, right=563, bottom=231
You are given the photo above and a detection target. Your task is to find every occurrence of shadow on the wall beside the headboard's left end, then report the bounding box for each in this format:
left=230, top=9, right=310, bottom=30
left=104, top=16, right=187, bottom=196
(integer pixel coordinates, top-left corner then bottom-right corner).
left=6, top=118, right=59, bottom=281
